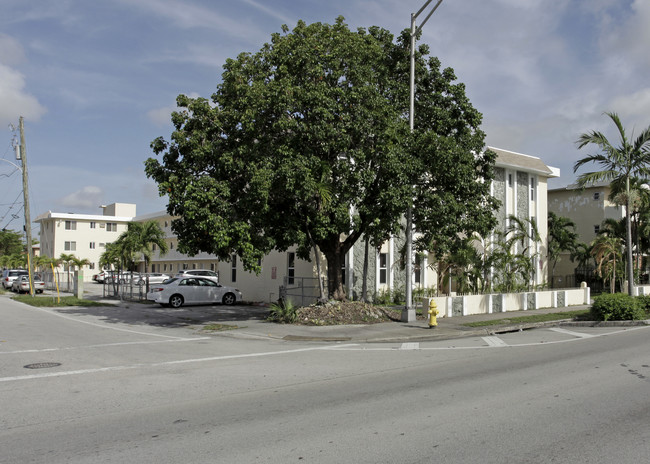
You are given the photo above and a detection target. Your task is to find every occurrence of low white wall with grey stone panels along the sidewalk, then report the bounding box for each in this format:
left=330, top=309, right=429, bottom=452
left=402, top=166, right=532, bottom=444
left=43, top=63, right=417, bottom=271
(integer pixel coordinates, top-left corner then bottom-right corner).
left=422, top=282, right=588, bottom=317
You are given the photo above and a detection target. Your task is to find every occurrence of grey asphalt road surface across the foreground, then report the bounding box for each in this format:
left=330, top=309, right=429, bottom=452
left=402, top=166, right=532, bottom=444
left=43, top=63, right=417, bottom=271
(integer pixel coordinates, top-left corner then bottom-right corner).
left=0, top=298, right=650, bottom=464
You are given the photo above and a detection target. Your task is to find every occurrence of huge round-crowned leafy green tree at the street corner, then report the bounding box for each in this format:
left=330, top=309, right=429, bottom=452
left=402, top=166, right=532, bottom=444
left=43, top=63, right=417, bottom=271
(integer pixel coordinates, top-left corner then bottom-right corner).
left=145, top=18, right=494, bottom=296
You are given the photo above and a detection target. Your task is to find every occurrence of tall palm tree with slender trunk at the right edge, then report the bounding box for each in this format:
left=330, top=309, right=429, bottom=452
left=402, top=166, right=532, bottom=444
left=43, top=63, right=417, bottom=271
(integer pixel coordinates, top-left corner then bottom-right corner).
left=573, top=113, right=650, bottom=295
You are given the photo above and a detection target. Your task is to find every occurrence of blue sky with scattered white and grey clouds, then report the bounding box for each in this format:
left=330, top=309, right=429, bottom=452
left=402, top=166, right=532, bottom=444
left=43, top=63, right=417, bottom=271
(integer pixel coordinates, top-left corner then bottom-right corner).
left=0, top=0, right=650, bottom=234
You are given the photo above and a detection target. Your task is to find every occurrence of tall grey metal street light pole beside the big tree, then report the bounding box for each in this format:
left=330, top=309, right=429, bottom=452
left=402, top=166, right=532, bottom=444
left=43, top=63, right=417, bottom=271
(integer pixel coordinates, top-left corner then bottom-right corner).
left=402, top=0, right=442, bottom=322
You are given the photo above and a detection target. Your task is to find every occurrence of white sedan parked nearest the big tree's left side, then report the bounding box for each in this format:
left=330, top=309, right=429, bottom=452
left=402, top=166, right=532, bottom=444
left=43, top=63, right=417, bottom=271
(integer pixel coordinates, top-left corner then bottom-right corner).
left=147, top=276, right=242, bottom=308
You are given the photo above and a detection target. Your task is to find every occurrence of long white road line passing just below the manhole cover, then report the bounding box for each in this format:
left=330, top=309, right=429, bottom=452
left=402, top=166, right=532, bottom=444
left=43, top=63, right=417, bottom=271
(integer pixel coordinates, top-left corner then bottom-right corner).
left=0, top=343, right=356, bottom=382
